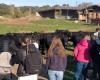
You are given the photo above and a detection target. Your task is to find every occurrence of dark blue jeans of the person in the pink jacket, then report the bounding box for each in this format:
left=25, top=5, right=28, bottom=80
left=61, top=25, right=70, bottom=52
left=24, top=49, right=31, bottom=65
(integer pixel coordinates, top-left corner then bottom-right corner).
left=75, top=61, right=88, bottom=80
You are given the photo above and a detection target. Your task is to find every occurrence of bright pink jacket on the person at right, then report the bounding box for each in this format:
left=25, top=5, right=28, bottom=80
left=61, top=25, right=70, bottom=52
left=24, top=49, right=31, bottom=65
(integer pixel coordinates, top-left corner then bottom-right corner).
left=74, top=39, right=91, bottom=62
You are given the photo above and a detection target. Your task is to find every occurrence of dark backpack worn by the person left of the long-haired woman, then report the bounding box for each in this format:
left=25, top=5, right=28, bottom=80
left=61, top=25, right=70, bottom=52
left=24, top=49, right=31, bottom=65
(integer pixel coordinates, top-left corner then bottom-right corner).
left=25, top=44, right=42, bottom=74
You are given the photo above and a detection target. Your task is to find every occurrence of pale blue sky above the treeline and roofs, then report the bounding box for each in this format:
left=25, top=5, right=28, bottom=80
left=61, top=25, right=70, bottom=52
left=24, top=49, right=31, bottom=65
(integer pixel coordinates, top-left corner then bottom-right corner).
left=0, top=0, right=100, bottom=6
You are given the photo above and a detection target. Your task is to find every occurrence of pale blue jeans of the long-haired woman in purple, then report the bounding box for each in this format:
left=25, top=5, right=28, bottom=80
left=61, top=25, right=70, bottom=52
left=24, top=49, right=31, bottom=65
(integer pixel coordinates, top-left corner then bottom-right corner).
left=48, top=70, right=64, bottom=80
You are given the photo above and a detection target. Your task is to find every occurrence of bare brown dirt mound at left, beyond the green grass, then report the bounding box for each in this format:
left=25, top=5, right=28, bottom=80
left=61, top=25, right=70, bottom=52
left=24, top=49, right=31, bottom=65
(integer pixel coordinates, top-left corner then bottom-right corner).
left=0, top=15, right=42, bottom=24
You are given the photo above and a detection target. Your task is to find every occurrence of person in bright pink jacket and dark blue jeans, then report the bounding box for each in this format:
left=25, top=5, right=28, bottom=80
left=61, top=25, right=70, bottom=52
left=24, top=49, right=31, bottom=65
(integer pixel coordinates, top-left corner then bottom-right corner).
left=74, top=34, right=91, bottom=80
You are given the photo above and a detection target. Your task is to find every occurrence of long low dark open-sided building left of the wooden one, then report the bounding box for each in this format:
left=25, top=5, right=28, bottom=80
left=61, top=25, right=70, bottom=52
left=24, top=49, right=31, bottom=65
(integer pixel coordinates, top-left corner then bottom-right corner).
left=38, top=6, right=78, bottom=19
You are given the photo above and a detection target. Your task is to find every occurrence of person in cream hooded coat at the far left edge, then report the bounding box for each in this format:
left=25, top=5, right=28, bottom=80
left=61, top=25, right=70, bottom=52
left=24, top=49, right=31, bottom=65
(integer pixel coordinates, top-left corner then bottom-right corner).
left=0, top=52, right=12, bottom=80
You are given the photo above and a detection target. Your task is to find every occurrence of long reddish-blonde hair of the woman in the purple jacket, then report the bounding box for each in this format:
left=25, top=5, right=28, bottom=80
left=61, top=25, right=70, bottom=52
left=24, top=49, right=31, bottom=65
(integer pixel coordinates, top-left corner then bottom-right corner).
left=48, top=36, right=65, bottom=57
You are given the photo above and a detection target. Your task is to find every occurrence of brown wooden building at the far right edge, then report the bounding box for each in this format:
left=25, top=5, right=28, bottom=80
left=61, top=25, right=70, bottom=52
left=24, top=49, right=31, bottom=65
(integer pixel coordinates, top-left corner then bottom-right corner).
left=78, top=5, right=100, bottom=22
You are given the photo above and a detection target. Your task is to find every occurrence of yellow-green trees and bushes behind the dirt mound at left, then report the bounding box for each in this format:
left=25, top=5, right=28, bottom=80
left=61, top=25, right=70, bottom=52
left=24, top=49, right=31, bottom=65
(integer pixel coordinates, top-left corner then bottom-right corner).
left=0, top=3, right=36, bottom=18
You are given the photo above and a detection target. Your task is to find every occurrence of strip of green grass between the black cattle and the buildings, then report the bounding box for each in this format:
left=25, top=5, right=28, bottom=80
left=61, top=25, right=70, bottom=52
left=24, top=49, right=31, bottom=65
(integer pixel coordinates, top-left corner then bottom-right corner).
left=0, top=19, right=96, bottom=34
